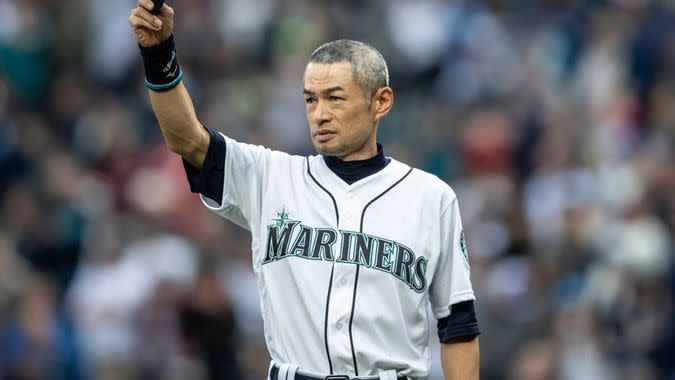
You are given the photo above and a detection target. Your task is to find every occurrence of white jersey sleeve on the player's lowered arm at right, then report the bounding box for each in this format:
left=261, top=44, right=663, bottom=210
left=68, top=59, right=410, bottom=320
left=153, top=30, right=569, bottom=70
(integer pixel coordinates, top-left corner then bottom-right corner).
left=429, top=196, right=476, bottom=320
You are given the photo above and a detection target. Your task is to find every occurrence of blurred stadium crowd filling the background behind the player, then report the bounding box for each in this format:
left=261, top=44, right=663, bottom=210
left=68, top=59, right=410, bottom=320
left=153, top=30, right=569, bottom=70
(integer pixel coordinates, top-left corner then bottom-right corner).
left=0, top=0, right=675, bottom=380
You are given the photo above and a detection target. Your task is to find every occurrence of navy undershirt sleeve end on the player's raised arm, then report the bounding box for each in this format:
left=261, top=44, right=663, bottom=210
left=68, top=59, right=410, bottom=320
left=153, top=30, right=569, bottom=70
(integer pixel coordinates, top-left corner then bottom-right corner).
left=183, top=128, right=227, bottom=205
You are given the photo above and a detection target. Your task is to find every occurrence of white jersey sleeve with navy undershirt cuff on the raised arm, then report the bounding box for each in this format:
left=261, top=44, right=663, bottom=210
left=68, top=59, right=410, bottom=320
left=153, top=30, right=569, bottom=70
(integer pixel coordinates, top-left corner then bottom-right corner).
left=184, top=130, right=272, bottom=231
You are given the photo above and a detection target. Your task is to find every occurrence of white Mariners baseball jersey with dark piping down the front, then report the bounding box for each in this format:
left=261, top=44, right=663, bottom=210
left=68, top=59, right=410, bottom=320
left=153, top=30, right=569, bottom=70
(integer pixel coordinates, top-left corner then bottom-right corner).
left=202, top=133, right=475, bottom=378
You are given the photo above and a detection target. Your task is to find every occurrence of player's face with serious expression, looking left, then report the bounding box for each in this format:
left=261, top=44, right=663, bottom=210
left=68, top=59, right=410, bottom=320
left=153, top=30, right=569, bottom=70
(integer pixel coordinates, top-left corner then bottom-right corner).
left=303, top=62, right=377, bottom=160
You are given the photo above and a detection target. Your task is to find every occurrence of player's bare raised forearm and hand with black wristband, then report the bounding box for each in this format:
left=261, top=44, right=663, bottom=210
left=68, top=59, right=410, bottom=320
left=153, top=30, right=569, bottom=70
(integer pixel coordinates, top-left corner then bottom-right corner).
left=129, top=0, right=210, bottom=169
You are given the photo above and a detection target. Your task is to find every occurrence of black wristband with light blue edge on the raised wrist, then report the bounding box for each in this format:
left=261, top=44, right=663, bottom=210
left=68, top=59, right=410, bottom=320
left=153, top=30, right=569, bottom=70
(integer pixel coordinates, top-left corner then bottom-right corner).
left=139, top=34, right=183, bottom=91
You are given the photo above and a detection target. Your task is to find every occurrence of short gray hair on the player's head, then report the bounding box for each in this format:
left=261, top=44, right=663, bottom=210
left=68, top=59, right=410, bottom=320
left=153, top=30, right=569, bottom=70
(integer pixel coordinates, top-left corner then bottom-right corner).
left=309, top=40, right=389, bottom=106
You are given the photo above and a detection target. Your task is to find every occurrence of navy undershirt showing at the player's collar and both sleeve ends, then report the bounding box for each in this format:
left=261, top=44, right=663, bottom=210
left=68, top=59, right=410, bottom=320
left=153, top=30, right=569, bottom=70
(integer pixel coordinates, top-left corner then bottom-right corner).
left=183, top=128, right=480, bottom=343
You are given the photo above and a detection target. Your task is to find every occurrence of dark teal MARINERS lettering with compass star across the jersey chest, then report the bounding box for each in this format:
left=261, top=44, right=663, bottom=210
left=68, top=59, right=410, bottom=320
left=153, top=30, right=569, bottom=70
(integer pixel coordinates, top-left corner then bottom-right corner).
left=261, top=208, right=428, bottom=293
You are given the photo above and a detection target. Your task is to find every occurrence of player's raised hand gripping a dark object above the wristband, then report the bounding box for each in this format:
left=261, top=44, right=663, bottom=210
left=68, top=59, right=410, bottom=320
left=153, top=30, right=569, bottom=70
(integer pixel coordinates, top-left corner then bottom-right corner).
left=129, top=0, right=173, bottom=47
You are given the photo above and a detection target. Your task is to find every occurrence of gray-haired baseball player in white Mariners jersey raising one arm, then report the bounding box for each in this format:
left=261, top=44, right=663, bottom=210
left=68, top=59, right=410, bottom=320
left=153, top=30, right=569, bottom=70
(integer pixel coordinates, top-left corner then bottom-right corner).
left=129, top=0, right=479, bottom=380
